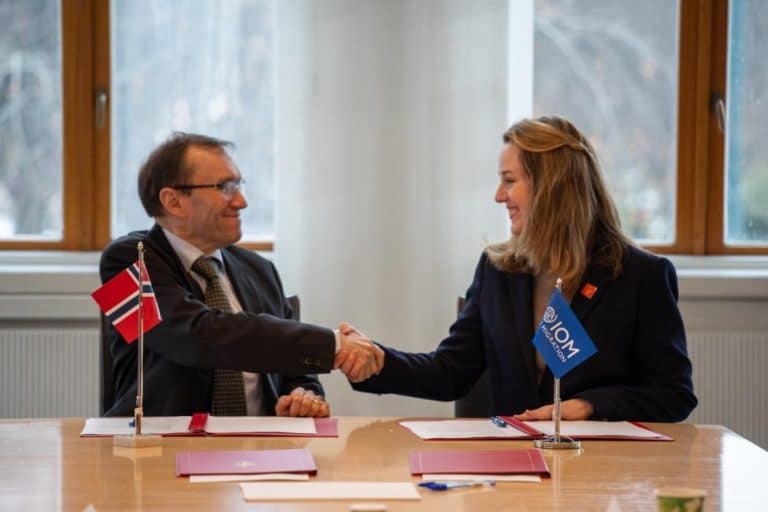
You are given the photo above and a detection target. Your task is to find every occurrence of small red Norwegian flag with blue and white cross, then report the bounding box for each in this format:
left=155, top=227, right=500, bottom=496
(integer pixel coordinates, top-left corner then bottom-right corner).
left=91, top=261, right=162, bottom=343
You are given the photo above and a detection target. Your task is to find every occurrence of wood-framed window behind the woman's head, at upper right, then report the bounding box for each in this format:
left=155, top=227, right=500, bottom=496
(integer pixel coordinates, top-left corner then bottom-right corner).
left=534, top=0, right=768, bottom=254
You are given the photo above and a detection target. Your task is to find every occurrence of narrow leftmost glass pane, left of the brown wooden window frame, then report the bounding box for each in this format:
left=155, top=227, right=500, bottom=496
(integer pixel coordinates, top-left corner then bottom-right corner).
left=0, top=0, right=63, bottom=241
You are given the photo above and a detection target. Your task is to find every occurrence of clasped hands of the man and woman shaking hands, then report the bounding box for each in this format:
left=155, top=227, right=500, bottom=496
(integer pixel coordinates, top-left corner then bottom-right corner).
left=333, top=322, right=384, bottom=382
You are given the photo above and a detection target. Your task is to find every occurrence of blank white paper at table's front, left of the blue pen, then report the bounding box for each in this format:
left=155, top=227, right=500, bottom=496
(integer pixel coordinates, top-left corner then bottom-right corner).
left=240, top=481, right=421, bottom=501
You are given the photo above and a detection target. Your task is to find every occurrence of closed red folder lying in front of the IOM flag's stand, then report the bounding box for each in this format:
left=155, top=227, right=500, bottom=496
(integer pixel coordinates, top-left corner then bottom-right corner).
left=410, top=449, right=549, bottom=476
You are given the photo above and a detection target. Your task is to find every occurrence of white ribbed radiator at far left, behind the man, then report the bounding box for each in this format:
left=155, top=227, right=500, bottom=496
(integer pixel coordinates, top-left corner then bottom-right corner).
left=0, top=326, right=99, bottom=418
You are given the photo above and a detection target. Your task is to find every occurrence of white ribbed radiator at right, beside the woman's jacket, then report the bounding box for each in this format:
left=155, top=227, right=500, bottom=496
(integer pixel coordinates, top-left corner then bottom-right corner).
left=688, top=331, right=768, bottom=448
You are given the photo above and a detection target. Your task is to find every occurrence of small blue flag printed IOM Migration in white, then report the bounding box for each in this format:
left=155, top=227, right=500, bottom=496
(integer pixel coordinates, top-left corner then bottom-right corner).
left=533, top=290, right=597, bottom=379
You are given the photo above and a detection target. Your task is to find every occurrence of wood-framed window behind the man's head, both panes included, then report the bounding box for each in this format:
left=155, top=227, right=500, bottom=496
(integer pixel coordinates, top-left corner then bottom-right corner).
left=0, top=0, right=275, bottom=250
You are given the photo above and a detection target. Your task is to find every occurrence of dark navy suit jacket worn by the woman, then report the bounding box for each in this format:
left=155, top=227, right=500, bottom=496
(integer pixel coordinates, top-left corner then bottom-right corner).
left=353, top=248, right=697, bottom=421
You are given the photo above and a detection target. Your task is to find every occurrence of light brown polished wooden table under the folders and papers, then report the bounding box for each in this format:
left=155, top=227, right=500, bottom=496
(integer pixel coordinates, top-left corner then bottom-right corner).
left=0, top=417, right=768, bottom=512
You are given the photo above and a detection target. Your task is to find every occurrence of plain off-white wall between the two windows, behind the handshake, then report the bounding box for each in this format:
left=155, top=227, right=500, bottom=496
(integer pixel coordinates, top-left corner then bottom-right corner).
left=275, top=0, right=507, bottom=415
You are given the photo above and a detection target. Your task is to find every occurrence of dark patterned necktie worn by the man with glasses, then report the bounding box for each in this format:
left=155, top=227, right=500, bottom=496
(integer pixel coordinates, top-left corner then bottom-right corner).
left=192, top=257, right=247, bottom=416
